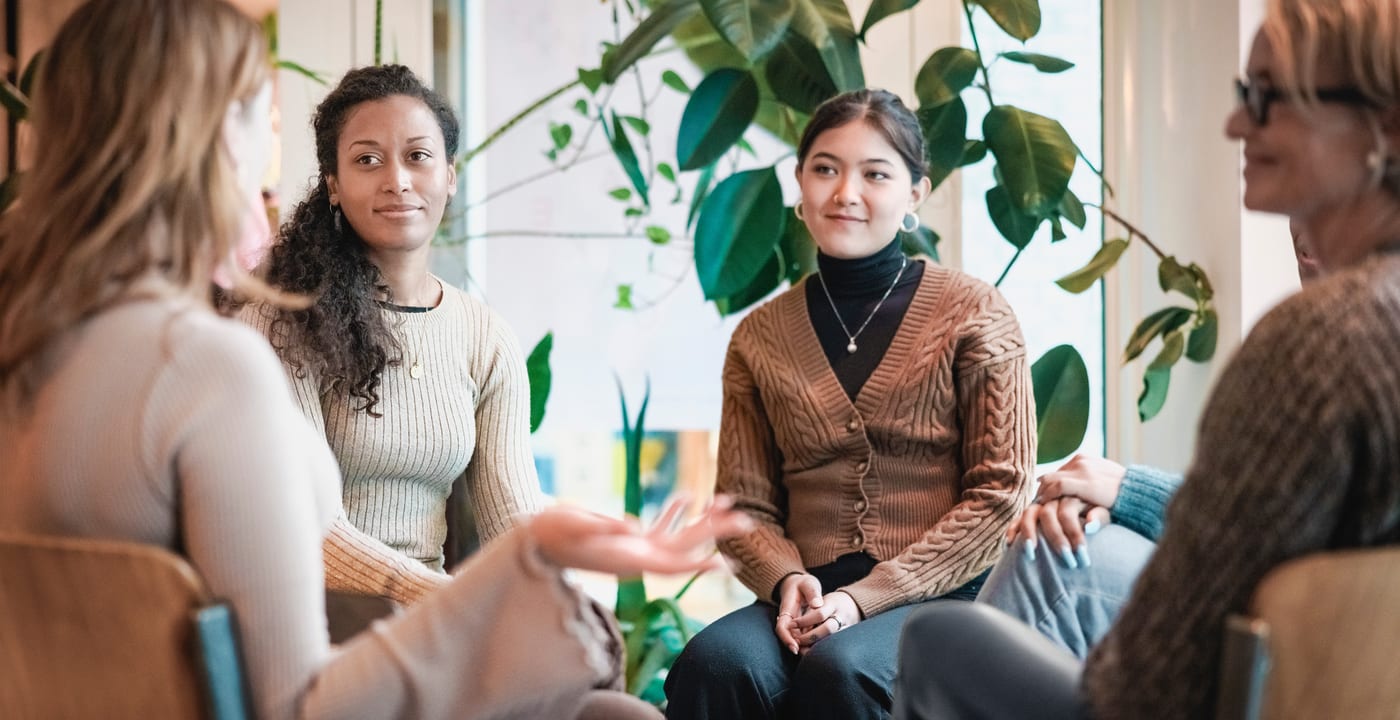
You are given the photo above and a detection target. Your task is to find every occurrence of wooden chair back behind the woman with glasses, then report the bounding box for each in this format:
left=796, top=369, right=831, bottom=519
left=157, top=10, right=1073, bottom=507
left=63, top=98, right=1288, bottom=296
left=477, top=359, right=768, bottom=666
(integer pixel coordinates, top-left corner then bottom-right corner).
left=1217, top=548, right=1400, bottom=720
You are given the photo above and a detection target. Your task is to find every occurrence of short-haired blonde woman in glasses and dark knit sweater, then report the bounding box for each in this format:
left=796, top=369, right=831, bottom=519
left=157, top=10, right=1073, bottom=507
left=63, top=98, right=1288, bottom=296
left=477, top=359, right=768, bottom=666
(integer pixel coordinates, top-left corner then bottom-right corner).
left=895, top=0, right=1400, bottom=719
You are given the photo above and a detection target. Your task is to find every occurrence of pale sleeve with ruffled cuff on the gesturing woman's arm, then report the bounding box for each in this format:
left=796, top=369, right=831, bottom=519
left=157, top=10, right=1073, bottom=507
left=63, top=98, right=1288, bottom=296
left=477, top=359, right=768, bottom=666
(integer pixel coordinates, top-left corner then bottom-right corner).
left=161, top=313, right=609, bottom=720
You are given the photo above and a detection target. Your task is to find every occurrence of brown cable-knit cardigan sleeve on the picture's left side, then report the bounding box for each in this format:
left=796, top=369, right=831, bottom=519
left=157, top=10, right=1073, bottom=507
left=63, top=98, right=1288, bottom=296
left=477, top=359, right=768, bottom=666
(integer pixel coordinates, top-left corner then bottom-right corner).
left=715, top=324, right=805, bottom=600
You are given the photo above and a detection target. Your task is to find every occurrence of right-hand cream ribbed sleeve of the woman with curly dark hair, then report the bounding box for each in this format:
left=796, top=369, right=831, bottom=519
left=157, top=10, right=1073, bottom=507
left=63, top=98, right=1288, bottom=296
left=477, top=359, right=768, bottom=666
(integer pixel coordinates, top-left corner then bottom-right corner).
left=465, top=305, right=545, bottom=544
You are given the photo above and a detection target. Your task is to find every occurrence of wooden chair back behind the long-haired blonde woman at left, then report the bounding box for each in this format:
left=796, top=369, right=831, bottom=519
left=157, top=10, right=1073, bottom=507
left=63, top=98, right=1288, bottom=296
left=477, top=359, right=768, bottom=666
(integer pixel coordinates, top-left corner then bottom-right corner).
left=0, top=534, right=252, bottom=720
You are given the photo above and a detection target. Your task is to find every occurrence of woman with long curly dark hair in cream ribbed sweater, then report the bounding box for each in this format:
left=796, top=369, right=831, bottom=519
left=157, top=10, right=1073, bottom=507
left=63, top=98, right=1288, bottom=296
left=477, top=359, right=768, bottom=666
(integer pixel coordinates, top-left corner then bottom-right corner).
left=242, top=66, right=542, bottom=605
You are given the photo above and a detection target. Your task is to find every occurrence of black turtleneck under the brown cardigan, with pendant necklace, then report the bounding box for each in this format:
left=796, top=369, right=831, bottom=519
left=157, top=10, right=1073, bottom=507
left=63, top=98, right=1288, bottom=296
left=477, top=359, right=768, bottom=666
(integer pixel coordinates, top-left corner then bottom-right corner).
left=806, top=238, right=924, bottom=401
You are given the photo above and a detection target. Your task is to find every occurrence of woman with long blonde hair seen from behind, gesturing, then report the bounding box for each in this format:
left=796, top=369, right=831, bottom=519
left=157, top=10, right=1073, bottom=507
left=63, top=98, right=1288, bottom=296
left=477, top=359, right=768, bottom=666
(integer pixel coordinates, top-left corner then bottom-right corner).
left=0, top=0, right=748, bottom=720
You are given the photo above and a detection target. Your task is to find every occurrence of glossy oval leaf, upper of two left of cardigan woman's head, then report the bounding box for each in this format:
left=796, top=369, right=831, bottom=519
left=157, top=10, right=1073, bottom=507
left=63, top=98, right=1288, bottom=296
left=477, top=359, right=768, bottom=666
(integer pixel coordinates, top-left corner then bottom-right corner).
left=676, top=67, right=759, bottom=169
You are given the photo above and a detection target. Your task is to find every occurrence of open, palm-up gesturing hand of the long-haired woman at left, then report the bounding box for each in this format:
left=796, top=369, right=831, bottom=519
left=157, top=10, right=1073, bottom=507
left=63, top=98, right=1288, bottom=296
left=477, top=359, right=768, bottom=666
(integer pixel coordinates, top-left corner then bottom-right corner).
left=528, top=496, right=753, bottom=576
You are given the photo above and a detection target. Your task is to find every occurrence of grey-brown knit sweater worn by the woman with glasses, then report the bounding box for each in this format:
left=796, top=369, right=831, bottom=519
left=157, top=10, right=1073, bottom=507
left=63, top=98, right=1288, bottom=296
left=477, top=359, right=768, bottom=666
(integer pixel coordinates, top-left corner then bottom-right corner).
left=1085, top=254, right=1400, bottom=719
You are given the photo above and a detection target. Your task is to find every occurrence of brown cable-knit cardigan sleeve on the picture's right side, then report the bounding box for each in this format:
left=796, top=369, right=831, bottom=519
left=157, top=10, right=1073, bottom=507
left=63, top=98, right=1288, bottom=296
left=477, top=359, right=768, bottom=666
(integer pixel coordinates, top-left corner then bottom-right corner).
left=843, top=287, right=1036, bottom=616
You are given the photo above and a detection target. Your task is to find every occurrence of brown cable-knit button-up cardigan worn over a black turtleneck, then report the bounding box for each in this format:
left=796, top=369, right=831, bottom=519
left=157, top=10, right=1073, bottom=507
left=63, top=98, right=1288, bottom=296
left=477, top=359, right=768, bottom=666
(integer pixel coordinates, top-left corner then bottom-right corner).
left=717, top=261, right=1036, bottom=616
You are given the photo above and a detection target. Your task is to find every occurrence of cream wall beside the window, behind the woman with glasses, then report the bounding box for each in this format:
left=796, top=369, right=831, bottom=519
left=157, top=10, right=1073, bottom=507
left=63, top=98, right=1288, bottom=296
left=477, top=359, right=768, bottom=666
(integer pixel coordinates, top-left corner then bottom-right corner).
left=1105, top=0, right=1296, bottom=469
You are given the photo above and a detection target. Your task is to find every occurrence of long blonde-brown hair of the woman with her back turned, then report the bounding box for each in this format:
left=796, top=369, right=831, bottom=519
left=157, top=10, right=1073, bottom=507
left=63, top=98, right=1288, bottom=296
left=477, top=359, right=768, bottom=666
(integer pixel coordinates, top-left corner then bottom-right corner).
left=0, top=0, right=270, bottom=401
